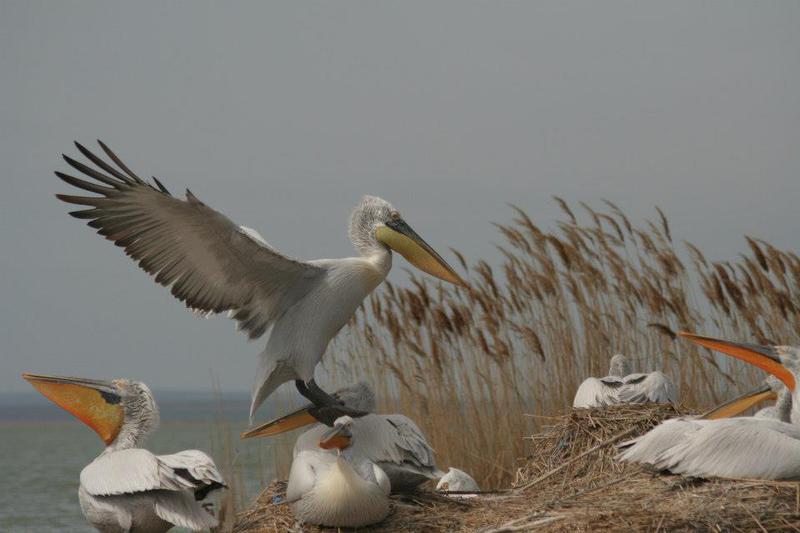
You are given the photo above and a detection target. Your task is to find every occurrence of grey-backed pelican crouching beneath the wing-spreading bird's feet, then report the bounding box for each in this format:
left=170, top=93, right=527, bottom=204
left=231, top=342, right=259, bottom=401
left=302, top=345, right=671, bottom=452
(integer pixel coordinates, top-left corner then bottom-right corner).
left=242, top=382, right=444, bottom=492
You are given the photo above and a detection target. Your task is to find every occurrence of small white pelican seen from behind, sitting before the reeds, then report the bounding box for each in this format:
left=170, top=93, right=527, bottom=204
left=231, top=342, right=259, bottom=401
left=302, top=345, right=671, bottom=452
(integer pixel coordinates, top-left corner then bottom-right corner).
left=572, top=354, right=678, bottom=408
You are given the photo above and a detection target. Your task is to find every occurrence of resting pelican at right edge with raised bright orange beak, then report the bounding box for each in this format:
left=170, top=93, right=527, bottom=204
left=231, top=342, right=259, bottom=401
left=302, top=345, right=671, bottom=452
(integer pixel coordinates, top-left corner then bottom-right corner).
left=619, top=333, right=800, bottom=480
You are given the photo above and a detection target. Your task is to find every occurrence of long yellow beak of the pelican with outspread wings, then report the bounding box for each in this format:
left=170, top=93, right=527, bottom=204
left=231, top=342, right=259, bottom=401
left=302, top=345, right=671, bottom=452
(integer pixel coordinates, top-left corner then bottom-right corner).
left=375, top=219, right=467, bottom=287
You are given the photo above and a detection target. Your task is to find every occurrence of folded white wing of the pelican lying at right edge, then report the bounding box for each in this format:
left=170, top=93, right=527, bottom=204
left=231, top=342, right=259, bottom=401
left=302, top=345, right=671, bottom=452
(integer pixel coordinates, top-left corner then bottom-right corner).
left=655, top=418, right=800, bottom=480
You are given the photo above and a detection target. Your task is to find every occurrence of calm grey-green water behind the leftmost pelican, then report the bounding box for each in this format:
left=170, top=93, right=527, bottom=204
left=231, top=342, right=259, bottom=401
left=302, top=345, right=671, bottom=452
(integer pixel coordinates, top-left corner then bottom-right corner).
left=0, top=392, right=298, bottom=533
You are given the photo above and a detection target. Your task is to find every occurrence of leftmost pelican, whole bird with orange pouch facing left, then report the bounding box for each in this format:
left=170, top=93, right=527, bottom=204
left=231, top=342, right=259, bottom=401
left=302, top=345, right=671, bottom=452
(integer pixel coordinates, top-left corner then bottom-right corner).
left=22, top=374, right=225, bottom=533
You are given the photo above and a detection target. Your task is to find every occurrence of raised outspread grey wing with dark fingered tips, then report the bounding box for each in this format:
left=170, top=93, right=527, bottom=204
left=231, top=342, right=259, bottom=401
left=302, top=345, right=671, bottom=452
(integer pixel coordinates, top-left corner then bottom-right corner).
left=56, top=141, right=325, bottom=339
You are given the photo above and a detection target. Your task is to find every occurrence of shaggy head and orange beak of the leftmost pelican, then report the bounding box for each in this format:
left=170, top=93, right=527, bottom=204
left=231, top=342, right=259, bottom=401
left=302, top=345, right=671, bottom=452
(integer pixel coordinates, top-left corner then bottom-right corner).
left=22, top=373, right=159, bottom=449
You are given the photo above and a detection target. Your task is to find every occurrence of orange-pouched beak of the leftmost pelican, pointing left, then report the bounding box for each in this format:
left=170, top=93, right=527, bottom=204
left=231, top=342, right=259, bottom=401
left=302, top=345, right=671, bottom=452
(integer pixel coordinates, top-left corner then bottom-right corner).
left=22, top=373, right=125, bottom=445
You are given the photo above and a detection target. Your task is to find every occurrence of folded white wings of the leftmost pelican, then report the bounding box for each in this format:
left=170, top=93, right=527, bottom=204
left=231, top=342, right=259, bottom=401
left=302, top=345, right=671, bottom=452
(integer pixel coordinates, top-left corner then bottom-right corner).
left=81, top=448, right=225, bottom=500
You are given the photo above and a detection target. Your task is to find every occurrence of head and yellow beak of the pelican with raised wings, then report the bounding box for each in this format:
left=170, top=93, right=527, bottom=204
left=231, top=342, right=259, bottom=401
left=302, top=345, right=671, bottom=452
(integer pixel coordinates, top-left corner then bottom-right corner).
left=350, top=196, right=466, bottom=286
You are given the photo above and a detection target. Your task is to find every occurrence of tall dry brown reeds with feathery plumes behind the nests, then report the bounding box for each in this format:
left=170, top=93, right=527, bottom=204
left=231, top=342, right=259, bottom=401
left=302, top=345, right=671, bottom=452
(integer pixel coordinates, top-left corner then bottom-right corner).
left=326, top=198, right=800, bottom=488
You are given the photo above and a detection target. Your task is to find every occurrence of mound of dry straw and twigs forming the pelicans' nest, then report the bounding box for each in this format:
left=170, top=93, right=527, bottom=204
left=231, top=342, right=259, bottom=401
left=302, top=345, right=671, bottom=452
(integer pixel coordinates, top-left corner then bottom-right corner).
left=234, top=405, right=800, bottom=533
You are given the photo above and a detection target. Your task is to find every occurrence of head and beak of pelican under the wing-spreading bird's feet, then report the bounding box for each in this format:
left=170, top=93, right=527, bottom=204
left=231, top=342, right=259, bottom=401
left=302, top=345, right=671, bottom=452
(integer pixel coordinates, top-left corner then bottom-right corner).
left=241, top=381, right=375, bottom=439
